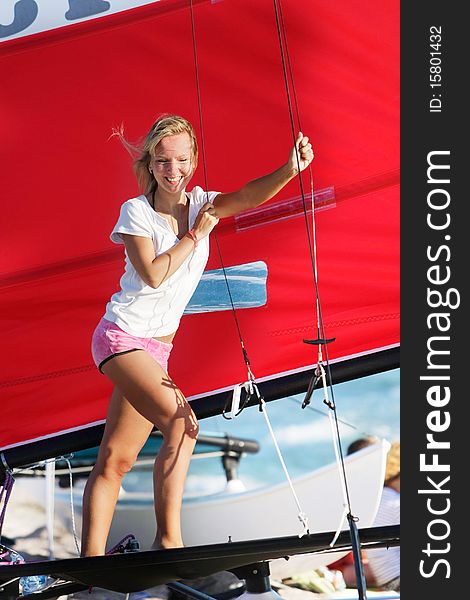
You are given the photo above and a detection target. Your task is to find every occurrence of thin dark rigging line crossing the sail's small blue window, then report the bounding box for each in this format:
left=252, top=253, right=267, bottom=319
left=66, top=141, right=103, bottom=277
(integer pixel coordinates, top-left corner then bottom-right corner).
left=189, top=0, right=254, bottom=372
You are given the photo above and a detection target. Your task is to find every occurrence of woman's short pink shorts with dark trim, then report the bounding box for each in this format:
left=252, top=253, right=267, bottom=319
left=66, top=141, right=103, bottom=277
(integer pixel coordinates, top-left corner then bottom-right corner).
left=91, top=318, right=173, bottom=373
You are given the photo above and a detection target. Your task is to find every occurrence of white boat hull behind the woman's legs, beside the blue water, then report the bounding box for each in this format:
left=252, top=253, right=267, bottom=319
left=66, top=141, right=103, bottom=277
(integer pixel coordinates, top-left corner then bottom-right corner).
left=52, top=440, right=390, bottom=579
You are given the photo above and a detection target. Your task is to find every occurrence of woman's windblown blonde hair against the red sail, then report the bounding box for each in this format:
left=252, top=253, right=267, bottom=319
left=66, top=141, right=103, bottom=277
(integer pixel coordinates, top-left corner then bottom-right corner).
left=112, top=114, right=198, bottom=194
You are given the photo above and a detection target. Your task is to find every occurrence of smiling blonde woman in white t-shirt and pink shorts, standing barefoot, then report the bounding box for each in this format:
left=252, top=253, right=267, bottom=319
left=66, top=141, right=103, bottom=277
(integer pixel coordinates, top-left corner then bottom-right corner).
left=82, top=115, right=313, bottom=556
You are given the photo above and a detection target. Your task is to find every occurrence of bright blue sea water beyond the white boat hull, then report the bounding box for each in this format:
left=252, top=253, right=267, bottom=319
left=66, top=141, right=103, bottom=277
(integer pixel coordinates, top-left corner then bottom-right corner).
left=125, top=369, right=400, bottom=497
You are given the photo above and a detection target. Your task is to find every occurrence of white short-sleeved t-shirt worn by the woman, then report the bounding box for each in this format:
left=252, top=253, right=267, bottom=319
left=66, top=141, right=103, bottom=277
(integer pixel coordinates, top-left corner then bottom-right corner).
left=104, top=186, right=219, bottom=337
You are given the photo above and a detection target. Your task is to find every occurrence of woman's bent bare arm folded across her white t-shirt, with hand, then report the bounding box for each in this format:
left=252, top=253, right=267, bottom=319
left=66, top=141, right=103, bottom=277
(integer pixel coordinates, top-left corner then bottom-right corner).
left=121, top=203, right=219, bottom=288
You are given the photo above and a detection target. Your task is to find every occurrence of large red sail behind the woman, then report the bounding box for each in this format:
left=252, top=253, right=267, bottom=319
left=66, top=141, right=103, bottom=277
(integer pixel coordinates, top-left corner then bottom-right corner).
left=0, top=0, right=399, bottom=448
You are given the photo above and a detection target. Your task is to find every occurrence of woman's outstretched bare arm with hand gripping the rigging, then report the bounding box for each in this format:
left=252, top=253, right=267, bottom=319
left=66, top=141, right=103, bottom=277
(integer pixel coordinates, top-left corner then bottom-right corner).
left=213, top=133, right=313, bottom=218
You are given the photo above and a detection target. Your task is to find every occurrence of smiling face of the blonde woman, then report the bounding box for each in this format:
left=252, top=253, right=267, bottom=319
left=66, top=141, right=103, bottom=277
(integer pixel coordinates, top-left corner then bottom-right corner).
left=150, top=132, right=195, bottom=193
